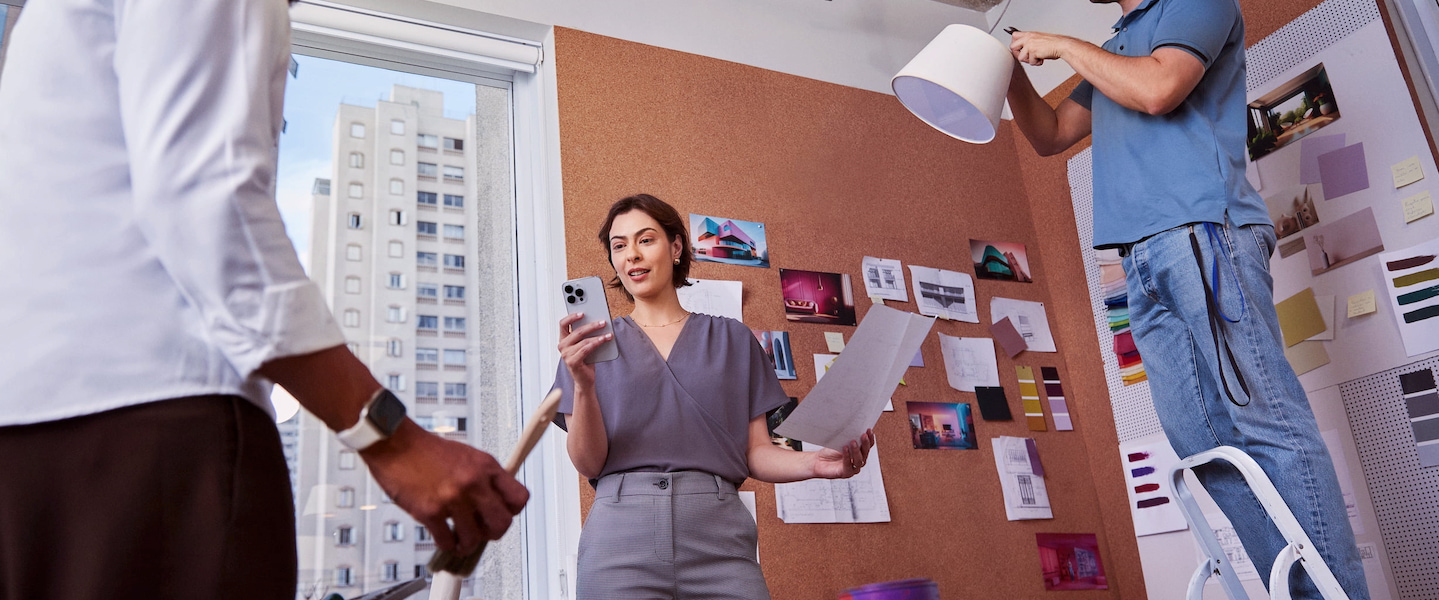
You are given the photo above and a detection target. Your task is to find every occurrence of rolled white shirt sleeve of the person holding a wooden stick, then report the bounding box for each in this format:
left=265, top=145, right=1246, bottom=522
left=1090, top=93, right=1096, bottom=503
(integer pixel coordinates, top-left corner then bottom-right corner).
left=114, top=0, right=344, bottom=377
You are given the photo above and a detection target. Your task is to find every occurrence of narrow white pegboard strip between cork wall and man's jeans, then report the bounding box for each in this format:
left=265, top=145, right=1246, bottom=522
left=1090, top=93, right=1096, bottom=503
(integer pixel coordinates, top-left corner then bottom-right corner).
left=1069, top=150, right=1161, bottom=443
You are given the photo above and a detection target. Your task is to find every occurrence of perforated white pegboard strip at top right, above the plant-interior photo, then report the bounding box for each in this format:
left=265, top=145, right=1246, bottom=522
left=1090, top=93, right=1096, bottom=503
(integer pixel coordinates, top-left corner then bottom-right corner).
left=1245, top=0, right=1379, bottom=92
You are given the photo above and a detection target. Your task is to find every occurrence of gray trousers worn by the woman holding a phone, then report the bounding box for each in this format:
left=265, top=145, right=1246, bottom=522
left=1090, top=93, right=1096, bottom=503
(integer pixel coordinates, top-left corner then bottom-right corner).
left=576, top=471, right=770, bottom=600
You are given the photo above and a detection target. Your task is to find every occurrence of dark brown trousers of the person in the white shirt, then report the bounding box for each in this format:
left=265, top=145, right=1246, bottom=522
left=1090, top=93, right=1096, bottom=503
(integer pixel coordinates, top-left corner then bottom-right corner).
left=0, top=396, right=296, bottom=600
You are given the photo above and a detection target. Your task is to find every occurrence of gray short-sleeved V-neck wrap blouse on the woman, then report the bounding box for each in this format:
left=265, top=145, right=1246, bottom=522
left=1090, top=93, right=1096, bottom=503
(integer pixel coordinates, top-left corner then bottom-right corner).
left=554, top=314, right=789, bottom=485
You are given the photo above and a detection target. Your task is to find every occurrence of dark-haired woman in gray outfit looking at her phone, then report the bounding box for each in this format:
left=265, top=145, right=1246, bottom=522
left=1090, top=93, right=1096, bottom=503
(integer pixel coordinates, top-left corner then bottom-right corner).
left=555, top=194, right=875, bottom=600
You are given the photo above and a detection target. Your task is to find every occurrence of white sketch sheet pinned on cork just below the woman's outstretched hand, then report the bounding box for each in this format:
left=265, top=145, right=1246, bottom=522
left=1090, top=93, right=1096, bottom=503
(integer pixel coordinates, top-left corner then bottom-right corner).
left=774, top=443, right=889, bottom=524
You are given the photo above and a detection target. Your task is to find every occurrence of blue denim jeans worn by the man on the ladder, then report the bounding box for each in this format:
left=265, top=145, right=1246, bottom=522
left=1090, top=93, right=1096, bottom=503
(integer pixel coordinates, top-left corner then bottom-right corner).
left=1124, top=223, right=1368, bottom=600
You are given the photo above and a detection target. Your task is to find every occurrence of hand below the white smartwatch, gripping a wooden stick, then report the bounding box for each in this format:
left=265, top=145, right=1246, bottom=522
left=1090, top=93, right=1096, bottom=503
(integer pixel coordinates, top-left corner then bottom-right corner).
left=360, top=419, right=530, bottom=554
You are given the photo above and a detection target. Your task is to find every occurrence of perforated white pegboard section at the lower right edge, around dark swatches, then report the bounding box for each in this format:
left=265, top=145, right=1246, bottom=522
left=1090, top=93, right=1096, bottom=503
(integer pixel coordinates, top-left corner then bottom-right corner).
left=1340, top=357, right=1439, bottom=600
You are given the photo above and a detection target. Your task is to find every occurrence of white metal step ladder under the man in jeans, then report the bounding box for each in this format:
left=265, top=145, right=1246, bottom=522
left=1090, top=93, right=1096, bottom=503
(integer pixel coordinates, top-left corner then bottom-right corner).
left=1170, top=446, right=1348, bottom=600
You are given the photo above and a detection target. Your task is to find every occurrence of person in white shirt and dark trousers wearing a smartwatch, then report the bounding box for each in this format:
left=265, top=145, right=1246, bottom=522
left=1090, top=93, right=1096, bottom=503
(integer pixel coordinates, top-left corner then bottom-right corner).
left=0, top=0, right=528, bottom=599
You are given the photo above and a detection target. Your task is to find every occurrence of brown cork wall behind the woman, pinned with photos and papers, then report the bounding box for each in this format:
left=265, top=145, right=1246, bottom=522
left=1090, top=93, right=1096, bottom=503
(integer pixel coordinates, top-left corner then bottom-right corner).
left=555, top=29, right=1145, bottom=599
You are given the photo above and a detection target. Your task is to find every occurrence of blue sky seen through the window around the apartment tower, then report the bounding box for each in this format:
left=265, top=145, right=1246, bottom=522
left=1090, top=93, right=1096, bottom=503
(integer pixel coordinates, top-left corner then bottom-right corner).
left=275, top=55, right=475, bottom=269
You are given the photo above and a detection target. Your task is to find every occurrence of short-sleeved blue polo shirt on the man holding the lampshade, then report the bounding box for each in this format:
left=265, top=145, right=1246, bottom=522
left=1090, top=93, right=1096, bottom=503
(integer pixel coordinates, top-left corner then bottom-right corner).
left=1069, top=0, right=1269, bottom=247
